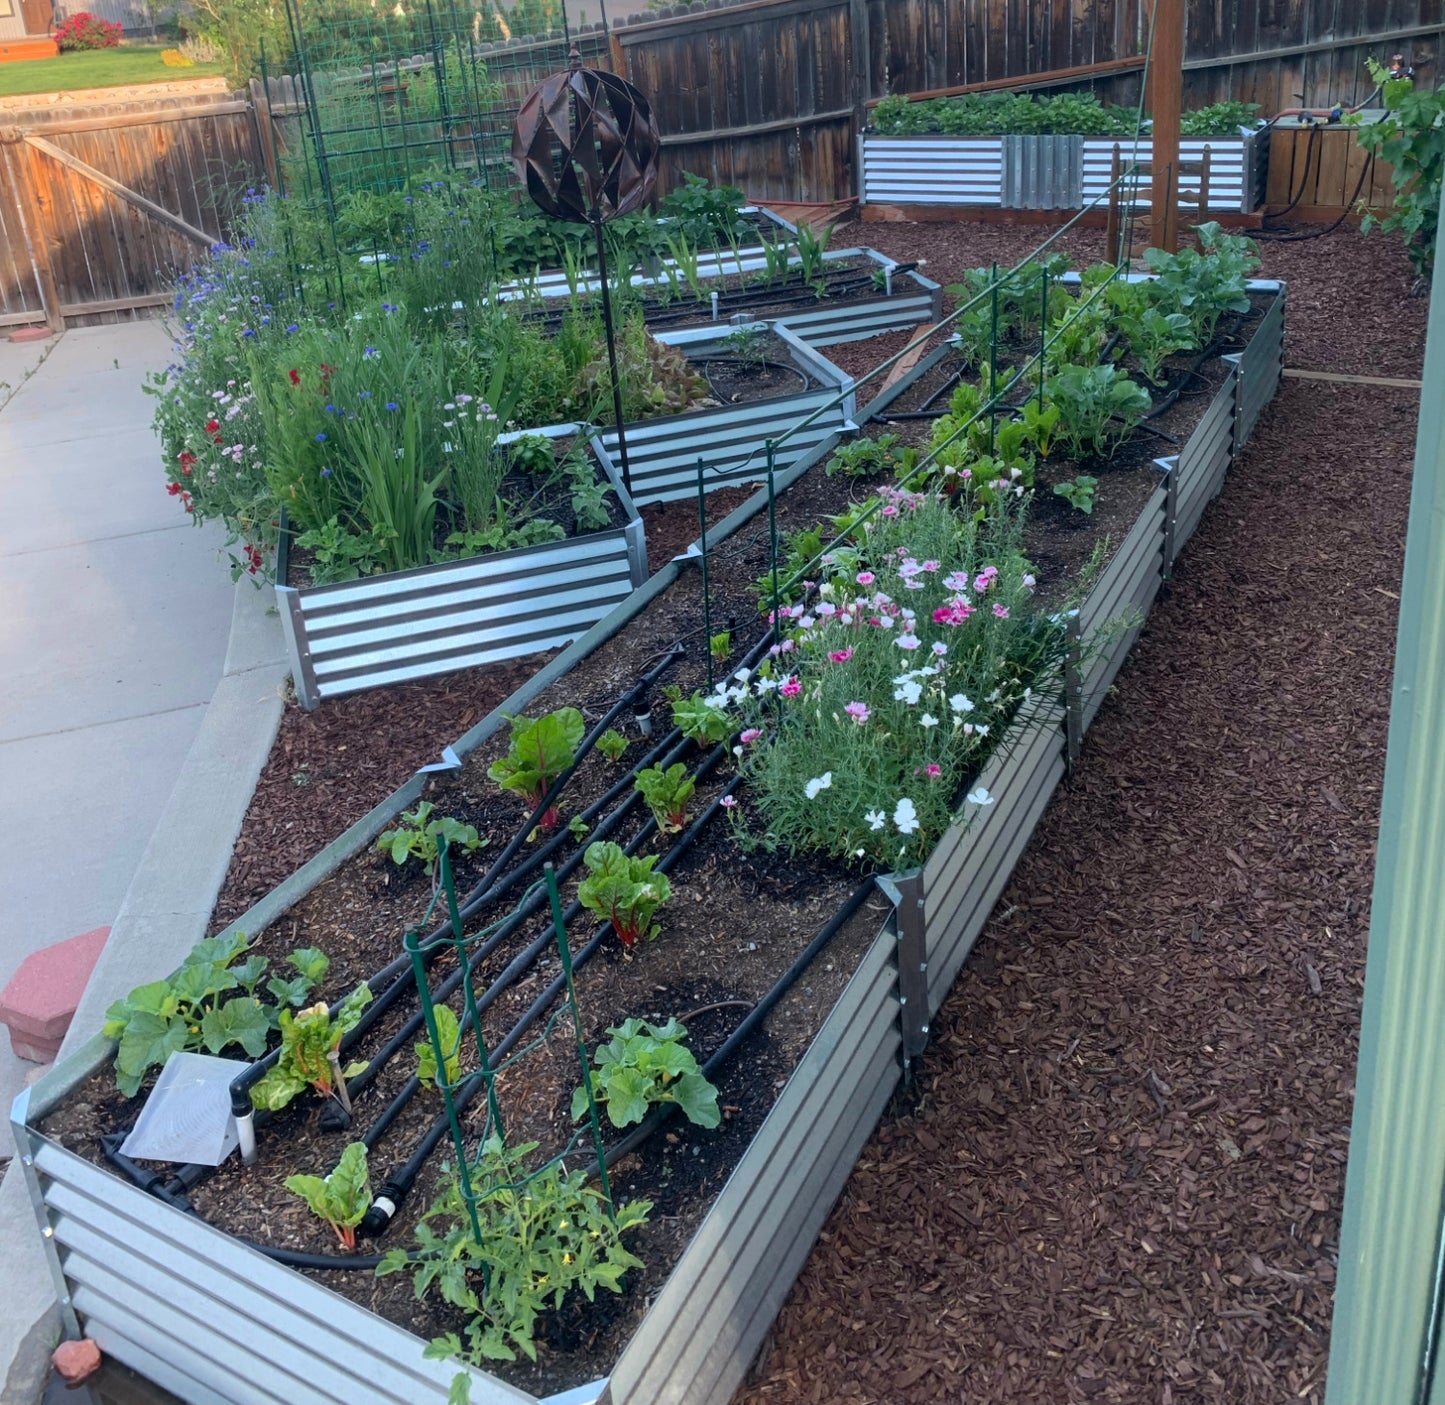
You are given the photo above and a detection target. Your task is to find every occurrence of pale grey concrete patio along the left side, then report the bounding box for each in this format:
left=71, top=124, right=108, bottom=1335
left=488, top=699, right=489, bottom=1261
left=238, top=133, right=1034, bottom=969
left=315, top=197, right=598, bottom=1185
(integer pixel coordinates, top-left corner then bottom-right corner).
left=0, top=322, right=290, bottom=1405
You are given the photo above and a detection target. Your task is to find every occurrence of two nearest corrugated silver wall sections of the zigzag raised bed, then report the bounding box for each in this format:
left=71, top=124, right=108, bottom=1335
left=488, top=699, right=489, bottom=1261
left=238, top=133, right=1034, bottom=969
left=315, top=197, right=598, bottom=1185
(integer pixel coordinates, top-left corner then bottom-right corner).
left=276, top=327, right=853, bottom=711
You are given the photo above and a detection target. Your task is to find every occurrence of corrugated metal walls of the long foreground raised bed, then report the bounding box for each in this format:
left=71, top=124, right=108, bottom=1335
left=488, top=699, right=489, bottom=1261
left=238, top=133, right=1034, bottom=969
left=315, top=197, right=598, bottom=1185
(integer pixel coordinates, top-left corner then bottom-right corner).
left=12, top=283, right=1283, bottom=1405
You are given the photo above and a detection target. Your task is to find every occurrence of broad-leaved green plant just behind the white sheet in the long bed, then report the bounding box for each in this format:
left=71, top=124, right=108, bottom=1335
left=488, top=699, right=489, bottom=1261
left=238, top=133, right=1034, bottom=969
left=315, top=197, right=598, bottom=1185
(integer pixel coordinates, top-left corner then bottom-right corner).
left=101, top=932, right=280, bottom=1097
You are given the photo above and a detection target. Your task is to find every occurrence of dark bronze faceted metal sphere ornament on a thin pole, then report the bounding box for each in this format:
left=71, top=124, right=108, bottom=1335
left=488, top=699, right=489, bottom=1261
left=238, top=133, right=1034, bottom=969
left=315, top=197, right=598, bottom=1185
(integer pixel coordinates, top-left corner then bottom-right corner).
left=512, top=43, right=660, bottom=491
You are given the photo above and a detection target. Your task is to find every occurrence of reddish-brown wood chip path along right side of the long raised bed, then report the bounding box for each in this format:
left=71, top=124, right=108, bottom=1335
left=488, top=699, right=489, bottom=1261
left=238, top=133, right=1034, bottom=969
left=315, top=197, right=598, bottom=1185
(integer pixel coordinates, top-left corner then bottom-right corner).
left=737, top=375, right=1415, bottom=1405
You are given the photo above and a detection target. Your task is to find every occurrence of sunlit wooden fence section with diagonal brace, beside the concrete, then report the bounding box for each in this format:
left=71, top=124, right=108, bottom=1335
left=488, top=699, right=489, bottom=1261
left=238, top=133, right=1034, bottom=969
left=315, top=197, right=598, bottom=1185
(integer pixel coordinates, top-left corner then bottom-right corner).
left=0, top=94, right=263, bottom=328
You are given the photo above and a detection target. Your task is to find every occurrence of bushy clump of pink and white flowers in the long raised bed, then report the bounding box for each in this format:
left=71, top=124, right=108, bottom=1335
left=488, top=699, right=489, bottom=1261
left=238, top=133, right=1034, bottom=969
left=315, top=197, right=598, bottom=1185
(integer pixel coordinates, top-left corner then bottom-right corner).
left=711, top=489, right=1064, bottom=867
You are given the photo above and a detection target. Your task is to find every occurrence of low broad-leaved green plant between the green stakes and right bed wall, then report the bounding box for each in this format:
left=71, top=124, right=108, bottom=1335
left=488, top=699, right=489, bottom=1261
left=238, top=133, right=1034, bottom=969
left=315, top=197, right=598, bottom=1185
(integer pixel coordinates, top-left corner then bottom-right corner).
left=572, top=1019, right=723, bottom=1127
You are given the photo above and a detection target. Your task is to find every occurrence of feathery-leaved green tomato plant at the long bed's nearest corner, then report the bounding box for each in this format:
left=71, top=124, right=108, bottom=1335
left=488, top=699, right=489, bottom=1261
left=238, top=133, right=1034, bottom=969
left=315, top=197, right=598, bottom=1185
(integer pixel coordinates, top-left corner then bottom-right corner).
left=377, top=1138, right=652, bottom=1365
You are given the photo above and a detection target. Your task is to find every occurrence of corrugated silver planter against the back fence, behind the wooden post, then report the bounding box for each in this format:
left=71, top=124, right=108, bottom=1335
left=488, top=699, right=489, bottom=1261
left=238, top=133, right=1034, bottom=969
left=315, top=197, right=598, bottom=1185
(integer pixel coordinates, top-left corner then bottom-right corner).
left=858, top=132, right=1269, bottom=214
